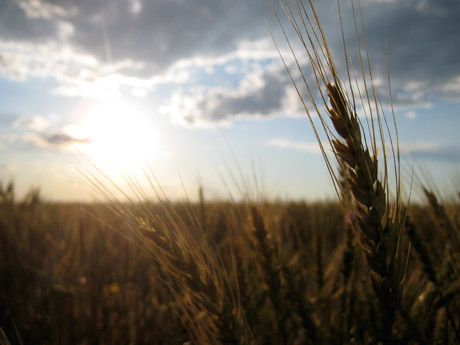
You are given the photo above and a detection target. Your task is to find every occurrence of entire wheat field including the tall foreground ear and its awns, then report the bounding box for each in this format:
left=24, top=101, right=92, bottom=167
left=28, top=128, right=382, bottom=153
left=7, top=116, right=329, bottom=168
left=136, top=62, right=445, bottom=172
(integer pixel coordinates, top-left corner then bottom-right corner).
left=0, top=1, right=460, bottom=345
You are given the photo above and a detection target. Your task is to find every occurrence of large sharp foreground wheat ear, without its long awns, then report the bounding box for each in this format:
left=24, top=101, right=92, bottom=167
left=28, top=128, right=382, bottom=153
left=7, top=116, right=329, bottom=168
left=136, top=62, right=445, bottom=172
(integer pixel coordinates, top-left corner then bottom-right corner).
left=327, top=84, right=402, bottom=338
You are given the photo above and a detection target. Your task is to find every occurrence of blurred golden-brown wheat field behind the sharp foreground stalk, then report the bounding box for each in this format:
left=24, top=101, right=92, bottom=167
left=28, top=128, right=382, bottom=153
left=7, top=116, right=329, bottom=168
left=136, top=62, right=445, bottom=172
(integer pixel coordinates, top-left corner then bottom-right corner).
left=0, top=181, right=460, bottom=344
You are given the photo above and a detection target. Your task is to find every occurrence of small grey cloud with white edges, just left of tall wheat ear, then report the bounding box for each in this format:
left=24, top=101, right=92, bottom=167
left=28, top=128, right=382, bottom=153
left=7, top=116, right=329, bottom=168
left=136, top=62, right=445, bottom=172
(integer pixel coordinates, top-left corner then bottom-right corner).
left=160, top=61, right=305, bottom=126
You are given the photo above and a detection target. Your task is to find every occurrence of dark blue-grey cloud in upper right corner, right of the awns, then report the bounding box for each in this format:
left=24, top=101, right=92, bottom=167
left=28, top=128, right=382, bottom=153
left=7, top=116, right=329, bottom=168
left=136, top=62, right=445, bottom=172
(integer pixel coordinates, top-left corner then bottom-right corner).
left=340, top=0, right=460, bottom=104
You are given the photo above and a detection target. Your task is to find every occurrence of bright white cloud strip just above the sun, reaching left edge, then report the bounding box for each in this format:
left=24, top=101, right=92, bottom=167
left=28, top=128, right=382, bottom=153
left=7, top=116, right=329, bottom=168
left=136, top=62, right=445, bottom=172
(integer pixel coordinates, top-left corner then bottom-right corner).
left=0, top=41, right=156, bottom=99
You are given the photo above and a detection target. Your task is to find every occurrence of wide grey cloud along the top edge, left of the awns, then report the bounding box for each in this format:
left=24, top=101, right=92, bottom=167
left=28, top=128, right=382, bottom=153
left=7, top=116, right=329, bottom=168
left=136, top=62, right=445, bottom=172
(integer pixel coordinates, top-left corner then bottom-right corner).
left=2, top=0, right=273, bottom=77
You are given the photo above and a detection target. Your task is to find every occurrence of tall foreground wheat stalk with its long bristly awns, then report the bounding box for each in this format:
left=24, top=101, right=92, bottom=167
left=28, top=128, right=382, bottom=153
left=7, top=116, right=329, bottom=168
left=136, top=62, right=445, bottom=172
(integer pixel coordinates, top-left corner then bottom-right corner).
left=275, top=0, right=405, bottom=344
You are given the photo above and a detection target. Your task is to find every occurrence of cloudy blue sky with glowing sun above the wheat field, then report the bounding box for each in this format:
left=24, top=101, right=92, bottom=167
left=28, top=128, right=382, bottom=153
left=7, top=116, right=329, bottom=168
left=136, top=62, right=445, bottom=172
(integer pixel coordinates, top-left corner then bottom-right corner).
left=0, top=0, right=460, bottom=201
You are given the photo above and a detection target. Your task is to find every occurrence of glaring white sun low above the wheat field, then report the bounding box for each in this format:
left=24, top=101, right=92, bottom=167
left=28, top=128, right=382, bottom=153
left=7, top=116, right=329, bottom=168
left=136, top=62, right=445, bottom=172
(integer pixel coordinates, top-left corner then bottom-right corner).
left=71, top=102, right=159, bottom=171
